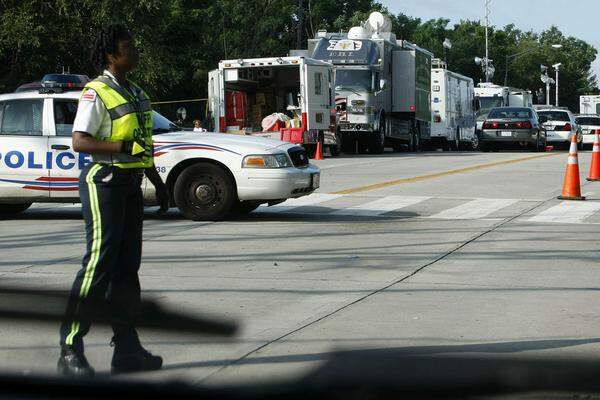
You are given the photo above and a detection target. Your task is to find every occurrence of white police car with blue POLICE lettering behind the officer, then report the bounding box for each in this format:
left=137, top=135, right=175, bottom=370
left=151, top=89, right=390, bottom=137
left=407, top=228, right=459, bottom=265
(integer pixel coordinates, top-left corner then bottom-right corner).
left=0, top=74, right=320, bottom=220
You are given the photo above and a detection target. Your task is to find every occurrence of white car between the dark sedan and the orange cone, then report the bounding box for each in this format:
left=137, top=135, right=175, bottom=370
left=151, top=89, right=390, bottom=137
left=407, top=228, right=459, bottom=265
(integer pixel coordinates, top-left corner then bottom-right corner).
left=537, top=107, right=583, bottom=150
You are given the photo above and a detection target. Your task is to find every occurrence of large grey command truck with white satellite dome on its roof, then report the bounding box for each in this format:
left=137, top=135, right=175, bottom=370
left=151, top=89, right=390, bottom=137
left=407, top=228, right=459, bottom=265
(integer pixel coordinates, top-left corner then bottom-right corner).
left=308, top=12, right=433, bottom=154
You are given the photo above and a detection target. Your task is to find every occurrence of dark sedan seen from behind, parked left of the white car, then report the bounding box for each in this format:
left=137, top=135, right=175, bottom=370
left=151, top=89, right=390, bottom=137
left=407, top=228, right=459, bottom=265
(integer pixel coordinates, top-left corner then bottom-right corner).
left=479, top=107, right=546, bottom=151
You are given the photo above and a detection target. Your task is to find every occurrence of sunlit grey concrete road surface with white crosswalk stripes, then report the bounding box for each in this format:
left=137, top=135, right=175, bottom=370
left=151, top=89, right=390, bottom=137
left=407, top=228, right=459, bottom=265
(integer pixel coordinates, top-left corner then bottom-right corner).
left=0, top=152, right=600, bottom=384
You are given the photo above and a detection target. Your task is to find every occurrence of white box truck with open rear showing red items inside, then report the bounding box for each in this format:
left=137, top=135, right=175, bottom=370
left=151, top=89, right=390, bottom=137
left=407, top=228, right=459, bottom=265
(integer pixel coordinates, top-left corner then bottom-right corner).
left=208, top=57, right=335, bottom=151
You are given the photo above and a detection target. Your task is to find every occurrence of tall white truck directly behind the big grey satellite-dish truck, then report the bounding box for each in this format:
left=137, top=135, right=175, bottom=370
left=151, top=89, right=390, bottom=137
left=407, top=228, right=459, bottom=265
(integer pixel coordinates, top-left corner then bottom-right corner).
left=431, top=58, right=478, bottom=151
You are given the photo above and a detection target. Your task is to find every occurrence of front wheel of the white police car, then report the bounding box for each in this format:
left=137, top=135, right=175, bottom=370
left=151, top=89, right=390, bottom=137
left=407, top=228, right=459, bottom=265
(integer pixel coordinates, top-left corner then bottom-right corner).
left=174, top=163, right=236, bottom=221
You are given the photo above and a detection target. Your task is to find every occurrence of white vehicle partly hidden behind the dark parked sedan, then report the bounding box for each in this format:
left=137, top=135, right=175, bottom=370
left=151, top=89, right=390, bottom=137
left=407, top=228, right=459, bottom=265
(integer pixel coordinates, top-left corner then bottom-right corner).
left=475, top=82, right=533, bottom=132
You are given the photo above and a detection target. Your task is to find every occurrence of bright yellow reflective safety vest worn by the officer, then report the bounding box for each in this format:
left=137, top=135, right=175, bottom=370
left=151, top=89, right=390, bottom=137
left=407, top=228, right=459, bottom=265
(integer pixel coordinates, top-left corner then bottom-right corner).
left=82, top=76, right=154, bottom=168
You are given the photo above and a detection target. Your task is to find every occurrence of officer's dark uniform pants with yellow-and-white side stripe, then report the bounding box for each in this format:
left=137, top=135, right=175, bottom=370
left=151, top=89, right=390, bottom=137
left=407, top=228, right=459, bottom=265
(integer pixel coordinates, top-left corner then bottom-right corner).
left=60, top=163, right=144, bottom=353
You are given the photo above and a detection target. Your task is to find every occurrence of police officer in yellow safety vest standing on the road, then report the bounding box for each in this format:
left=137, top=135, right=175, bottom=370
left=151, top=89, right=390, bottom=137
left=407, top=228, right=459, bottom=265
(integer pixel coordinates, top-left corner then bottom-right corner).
left=58, top=24, right=169, bottom=376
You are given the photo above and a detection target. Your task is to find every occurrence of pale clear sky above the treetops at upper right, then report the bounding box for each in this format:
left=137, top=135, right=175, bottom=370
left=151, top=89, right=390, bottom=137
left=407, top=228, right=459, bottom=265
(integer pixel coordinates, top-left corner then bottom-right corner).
left=379, top=0, right=600, bottom=78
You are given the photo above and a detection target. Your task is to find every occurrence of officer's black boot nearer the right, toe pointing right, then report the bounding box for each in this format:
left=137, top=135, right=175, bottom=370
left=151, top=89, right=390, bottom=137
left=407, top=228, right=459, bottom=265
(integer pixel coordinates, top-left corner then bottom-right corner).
left=111, top=339, right=162, bottom=374
